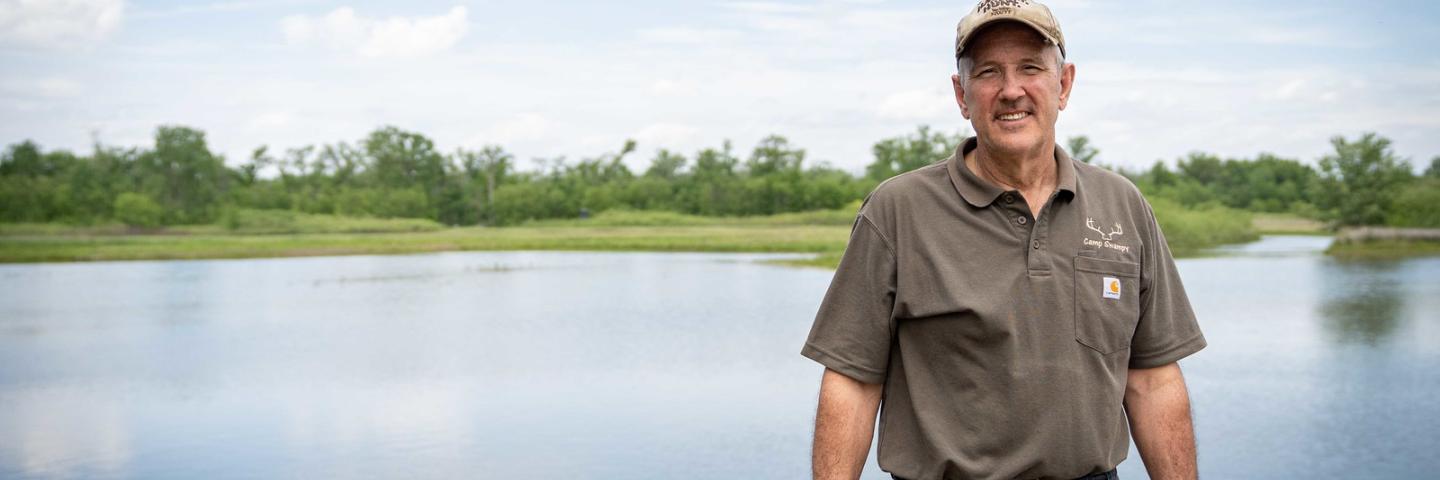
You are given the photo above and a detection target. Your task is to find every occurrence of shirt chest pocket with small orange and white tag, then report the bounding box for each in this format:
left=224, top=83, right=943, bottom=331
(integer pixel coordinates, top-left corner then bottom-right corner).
left=1074, top=257, right=1140, bottom=355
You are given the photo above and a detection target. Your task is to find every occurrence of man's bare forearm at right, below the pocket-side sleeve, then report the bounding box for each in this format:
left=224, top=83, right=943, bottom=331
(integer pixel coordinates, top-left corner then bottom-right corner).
left=1125, top=358, right=1200, bottom=480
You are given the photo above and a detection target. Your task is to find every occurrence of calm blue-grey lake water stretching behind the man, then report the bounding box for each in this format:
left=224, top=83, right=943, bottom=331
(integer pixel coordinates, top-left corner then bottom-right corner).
left=0, top=236, right=1440, bottom=479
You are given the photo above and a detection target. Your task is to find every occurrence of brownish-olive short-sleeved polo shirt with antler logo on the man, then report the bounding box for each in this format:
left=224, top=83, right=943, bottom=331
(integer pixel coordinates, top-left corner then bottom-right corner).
left=801, top=138, right=1205, bottom=479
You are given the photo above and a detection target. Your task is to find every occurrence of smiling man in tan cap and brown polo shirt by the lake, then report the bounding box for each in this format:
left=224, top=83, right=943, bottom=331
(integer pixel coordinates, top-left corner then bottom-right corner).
left=802, top=0, right=1205, bottom=480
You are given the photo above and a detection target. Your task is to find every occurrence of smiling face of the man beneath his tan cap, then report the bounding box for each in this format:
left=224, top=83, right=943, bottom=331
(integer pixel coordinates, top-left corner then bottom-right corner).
left=950, top=23, right=1074, bottom=156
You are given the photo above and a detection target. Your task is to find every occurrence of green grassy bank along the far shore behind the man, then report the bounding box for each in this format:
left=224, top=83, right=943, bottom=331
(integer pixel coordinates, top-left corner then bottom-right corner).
left=0, top=197, right=1254, bottom=268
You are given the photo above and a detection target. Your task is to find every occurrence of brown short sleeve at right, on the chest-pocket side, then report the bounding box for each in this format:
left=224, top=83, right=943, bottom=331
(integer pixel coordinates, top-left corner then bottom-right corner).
left=1130, top=202, right=1205, bottom=369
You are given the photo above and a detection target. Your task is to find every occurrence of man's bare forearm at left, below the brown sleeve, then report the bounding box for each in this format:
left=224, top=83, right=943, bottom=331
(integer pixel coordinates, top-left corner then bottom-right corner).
left=811, top=369, right=883, bottom=480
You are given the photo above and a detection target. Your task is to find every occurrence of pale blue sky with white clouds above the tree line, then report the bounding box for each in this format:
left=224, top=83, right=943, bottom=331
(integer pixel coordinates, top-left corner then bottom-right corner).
left=0, top=0, right=1440, bottom=172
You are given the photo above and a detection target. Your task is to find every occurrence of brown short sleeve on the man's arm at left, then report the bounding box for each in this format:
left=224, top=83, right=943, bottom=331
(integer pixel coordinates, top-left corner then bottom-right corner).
left=801, top=213, right=896, bottom=383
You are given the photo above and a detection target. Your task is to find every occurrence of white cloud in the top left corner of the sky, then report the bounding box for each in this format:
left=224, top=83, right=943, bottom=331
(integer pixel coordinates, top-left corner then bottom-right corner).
left=0, top=0, right=125, bottom=49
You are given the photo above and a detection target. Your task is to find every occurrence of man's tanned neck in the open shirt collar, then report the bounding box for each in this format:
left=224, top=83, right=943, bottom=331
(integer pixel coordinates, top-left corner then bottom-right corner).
left=965, top=141, right=1060, bottom=216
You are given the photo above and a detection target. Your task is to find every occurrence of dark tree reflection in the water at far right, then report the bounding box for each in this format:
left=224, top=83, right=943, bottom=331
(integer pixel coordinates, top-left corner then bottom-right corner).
left=1319, top=261, right=1405, bottom=346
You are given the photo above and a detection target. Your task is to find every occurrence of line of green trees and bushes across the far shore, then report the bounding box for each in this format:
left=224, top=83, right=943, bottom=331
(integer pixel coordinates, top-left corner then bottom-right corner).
left=0, top=125, right=1440, bottom=226
